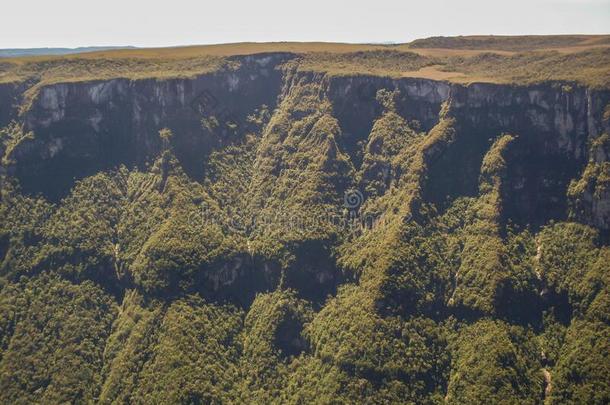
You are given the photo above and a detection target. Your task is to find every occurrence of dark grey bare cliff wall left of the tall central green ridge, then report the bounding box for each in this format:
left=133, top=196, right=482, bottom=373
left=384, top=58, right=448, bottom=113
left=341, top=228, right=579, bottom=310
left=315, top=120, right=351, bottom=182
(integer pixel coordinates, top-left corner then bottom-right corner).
left=10, top=54, right=286, bottom=198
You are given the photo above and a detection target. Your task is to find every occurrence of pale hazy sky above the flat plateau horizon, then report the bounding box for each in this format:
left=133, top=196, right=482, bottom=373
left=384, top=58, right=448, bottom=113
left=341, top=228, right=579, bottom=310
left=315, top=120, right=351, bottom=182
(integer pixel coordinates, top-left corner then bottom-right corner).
left=0, top=0, right=610, bottom=48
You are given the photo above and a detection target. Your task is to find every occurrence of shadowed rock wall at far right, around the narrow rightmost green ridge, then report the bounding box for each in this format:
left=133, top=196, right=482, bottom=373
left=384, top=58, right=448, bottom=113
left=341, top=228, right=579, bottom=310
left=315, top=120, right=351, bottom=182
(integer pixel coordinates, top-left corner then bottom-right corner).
left=438, top=84, right=608, bottom=229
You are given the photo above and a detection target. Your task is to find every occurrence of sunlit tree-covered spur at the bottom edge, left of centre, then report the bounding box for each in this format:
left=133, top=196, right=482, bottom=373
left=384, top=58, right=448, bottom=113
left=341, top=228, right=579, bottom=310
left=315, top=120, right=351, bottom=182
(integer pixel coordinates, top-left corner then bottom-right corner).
left=132, top=297, right=242, bottom=403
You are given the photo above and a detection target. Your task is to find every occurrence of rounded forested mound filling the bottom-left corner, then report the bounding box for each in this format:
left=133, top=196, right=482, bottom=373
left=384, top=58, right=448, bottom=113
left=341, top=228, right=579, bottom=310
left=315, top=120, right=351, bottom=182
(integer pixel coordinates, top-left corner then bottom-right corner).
left=0, top=274, right=116, bottom=403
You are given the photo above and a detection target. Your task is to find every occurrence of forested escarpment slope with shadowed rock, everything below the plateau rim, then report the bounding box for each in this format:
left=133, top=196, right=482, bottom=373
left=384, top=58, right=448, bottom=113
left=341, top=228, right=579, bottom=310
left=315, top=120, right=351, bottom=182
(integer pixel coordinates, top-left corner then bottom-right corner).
left=0, top=37, right=610, bottom=404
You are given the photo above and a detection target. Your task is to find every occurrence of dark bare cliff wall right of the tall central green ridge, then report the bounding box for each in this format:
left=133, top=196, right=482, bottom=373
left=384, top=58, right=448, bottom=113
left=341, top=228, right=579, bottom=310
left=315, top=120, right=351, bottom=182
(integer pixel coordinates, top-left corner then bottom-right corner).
left=328, top=73, right=610, bottom=229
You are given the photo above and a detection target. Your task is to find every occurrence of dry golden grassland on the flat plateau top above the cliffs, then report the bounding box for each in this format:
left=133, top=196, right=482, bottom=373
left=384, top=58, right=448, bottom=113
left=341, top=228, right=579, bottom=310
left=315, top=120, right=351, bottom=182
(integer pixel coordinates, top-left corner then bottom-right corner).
left=0, top=35, right=610, bottom=92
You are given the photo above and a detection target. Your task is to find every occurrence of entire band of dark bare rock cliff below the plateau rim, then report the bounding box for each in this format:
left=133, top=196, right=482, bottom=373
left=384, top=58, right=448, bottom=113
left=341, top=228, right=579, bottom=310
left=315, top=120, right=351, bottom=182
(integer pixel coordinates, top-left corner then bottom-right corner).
left=0, top=54, right=610, bottom=230
